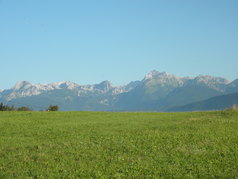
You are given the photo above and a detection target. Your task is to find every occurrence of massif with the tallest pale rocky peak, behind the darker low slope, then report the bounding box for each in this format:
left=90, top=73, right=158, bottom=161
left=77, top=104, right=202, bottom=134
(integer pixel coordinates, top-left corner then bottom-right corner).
left=114, top=71, right=232, bottom=111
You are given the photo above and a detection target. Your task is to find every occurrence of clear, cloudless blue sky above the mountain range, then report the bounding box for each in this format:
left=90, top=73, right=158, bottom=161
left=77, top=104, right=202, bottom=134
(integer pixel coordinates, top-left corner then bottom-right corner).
left=0, top=0, right=238, bottom=89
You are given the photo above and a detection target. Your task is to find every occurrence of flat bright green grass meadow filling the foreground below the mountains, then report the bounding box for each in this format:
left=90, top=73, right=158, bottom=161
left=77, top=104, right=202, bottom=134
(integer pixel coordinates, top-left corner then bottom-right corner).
left=0, top=110, right=238, bottom=179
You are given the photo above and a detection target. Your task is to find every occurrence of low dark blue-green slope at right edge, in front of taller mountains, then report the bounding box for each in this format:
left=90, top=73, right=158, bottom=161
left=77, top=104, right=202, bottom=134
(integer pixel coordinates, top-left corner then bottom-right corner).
left=167, top=93, right=238, bottom=112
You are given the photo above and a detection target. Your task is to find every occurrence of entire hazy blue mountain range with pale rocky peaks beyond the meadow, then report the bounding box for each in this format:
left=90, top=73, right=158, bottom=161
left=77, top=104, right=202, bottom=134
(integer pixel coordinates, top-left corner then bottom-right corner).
left=0, top=70, right=238, bottom=111
